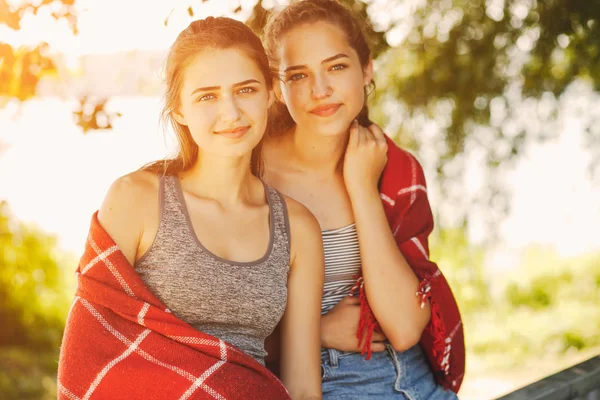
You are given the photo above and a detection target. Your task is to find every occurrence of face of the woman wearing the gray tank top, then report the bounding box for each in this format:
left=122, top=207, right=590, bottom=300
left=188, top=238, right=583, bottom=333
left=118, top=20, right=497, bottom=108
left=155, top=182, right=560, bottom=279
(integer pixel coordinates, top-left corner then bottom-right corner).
left=174, top=48, right=272, bottom=157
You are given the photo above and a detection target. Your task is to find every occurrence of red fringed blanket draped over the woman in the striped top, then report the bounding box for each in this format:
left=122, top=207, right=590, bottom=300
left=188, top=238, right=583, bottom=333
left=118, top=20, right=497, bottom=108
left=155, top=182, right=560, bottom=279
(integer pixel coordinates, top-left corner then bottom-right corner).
left=355, top=138, right=465, bottom=392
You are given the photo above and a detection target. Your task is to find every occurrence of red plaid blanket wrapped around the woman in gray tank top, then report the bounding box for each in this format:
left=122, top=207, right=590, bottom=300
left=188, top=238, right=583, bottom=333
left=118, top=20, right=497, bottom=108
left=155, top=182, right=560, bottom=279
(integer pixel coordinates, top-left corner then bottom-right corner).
left=58, top=213, right=289, bottom=400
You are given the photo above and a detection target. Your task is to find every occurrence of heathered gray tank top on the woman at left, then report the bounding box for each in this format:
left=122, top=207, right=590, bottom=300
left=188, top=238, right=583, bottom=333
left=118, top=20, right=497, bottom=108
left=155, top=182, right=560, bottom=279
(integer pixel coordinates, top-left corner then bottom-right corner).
left=135, top=176, right=290, bottom=364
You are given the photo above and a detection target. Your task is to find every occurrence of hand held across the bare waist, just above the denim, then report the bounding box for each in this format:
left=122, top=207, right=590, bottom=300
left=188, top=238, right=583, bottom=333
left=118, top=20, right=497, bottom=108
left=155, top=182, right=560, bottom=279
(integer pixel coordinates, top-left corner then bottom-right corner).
left=321, top=296, right=385, bottom=353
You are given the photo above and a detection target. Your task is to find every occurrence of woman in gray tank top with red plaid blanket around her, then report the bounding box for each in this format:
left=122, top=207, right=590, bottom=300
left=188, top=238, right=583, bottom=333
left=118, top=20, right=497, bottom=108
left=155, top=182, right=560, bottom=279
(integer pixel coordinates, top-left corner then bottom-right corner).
left=58, top=17, right=324, bottom=399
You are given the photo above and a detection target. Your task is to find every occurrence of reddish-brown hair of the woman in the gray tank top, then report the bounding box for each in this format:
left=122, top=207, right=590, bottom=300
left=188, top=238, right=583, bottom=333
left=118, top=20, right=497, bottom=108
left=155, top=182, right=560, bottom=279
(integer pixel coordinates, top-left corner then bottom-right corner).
left=142, top=17, right=273, bottom=177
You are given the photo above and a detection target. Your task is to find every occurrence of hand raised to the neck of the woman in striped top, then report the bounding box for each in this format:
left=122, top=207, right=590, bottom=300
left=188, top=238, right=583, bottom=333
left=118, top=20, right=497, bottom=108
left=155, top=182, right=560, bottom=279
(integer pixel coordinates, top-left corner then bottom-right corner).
left=344, top=121, right=387, bottom=198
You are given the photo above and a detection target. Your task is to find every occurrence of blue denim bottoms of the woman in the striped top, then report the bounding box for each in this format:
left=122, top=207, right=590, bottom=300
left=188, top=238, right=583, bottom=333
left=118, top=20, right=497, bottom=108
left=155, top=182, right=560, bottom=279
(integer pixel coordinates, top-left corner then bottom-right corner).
left=321, top=344, right=458, bottom=400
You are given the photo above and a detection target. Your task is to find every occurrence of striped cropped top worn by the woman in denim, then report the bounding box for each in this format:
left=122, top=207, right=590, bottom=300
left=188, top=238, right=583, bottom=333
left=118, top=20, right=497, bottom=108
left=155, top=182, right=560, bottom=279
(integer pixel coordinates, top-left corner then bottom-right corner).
left=321, top=224, right=361, bottom=314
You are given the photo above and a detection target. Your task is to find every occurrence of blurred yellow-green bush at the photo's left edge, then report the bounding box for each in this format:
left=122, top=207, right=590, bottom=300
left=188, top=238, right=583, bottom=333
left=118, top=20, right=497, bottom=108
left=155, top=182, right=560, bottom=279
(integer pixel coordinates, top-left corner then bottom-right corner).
left=0, top=202, right=74, bottom=348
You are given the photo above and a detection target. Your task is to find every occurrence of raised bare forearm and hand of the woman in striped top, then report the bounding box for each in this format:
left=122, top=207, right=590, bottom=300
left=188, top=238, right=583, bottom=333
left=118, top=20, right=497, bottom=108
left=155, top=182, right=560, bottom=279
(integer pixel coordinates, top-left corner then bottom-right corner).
left=344, top=126, right=431, bottom=351
